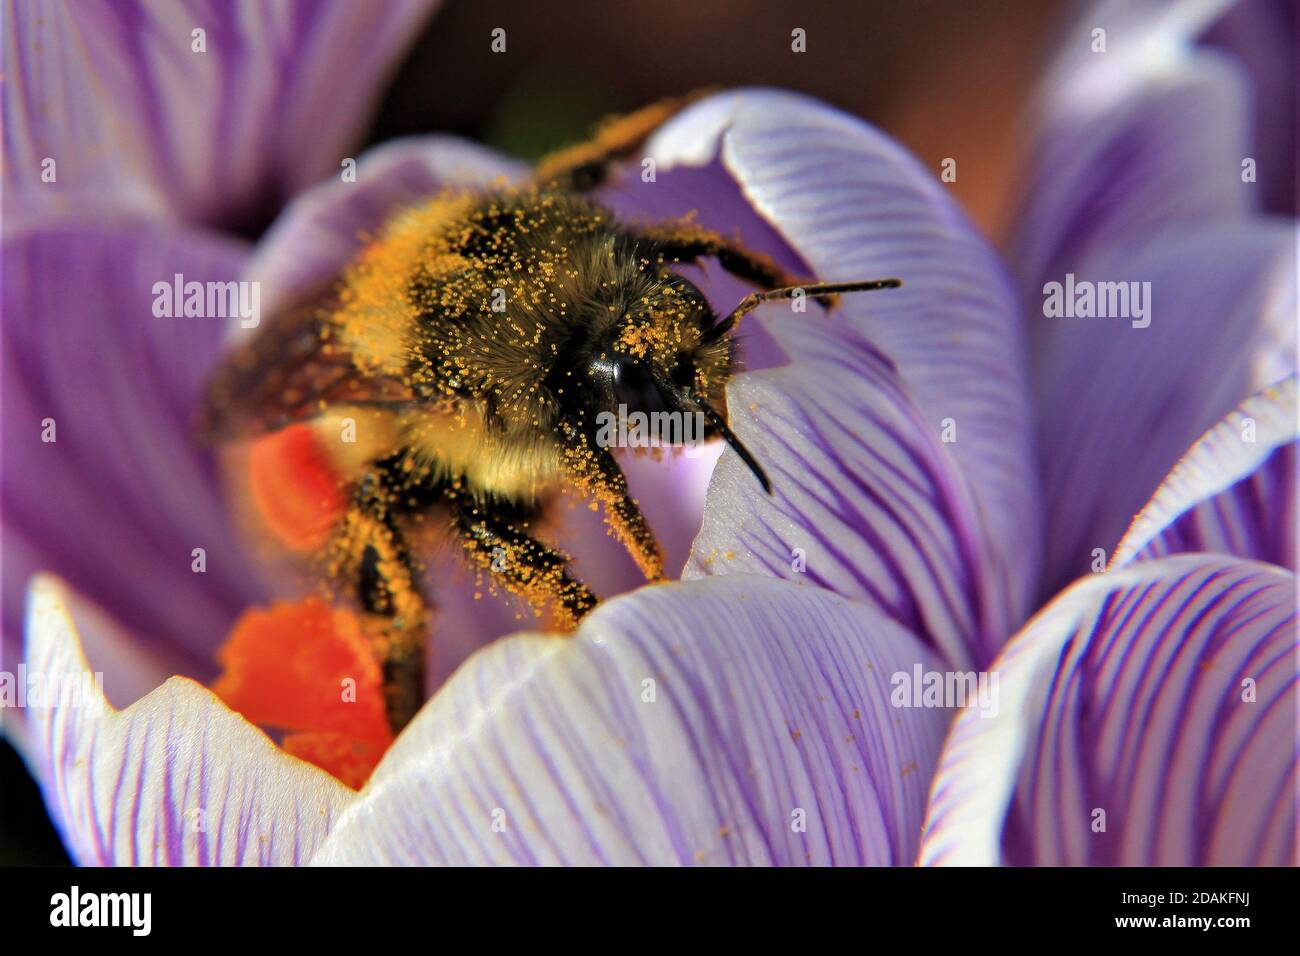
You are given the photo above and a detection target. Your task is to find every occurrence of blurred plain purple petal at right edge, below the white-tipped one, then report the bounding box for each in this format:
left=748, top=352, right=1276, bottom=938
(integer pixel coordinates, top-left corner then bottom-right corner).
left=1031, top=224, right=1296, bottom=588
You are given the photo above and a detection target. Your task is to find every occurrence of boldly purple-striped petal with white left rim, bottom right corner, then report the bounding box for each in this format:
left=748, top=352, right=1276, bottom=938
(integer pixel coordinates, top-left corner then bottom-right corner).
left=920, top=554, right=1300, bottom=866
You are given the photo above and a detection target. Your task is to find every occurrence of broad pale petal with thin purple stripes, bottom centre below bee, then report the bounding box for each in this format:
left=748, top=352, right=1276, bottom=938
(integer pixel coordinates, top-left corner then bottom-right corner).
left=312, top=575, right=949, bottom=865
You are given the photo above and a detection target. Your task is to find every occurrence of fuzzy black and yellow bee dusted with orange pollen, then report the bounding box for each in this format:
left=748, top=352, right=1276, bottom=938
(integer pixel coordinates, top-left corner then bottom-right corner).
left=203, top=95, right=900, bottom=731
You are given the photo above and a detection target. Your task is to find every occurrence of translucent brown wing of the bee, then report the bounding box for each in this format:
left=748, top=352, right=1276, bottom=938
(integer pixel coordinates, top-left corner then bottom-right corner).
left=198, top=293, right=417, bottom=442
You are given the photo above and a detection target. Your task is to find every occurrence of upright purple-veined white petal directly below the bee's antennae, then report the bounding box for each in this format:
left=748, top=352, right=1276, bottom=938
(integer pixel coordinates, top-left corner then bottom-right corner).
left=685, top=323, right=993, bottom=666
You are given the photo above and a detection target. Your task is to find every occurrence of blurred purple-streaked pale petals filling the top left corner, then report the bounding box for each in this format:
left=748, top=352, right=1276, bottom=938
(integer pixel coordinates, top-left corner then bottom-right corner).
left=4, top=0, right=437, bottom=229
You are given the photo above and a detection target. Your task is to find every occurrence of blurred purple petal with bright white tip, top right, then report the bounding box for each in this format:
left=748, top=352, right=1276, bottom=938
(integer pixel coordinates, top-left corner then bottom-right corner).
left=1009, top=0, right=1253, bottom=306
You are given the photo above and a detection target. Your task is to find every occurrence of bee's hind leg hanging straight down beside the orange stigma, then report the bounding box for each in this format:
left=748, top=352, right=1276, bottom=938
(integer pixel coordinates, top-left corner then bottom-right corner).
left=335, top=473, right=432, bottom=734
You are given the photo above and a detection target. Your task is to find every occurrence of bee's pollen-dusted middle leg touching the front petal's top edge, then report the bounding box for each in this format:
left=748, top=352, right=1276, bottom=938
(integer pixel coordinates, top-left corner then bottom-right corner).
left=446, top=485, right=597, bottom=627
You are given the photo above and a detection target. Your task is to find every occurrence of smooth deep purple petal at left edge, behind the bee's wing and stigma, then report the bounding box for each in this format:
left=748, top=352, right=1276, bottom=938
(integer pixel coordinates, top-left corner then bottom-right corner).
left=0, top=225, right=267, bottom=678
